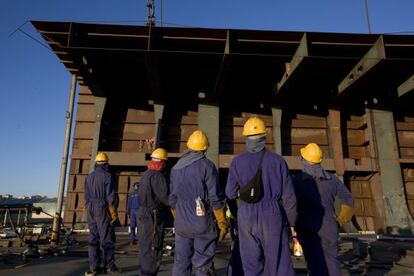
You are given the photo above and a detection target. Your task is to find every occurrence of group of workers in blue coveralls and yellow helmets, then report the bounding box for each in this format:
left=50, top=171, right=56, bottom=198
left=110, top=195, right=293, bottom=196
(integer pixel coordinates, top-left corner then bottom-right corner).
left=85, top=117, right=353, bottom=276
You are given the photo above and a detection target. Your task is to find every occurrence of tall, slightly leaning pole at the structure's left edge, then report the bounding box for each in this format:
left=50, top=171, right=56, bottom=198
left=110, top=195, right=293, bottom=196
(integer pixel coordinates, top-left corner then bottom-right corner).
left=51, top=74, right=76, bottom=245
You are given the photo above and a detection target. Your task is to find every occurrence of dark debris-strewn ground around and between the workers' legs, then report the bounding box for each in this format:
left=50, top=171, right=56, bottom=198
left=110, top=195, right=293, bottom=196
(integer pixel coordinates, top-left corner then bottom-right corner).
left=0, top=233, right=414, bottom=276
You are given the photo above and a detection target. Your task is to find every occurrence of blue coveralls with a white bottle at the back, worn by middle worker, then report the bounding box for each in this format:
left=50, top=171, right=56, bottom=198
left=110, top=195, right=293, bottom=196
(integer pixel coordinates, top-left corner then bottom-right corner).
left=170, top=157, right=225, bottom=276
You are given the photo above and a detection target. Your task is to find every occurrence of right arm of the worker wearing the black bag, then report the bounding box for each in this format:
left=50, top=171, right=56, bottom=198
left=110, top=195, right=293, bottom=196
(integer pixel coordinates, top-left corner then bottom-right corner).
left=280, top=159, right=297, bottom=227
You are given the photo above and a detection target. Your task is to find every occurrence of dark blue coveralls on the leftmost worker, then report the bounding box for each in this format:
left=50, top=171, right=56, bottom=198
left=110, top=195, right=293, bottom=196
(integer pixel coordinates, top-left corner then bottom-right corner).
left=85, top=164, right=116, bottom=271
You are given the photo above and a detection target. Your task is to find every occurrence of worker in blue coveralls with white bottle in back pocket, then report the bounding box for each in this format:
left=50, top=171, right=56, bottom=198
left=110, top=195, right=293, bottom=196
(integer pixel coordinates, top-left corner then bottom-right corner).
left=170, top=130, right=228, bottom=276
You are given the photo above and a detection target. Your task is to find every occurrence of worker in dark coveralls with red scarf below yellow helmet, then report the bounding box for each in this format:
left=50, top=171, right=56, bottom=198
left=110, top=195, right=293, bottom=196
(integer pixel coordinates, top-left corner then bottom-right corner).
left=138, top=148, right=169, bottom=276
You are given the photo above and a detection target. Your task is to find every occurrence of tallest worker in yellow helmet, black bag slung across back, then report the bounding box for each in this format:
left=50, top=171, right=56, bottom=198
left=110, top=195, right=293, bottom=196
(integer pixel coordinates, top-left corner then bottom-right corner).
left=226, top=117, right=297, bottom=276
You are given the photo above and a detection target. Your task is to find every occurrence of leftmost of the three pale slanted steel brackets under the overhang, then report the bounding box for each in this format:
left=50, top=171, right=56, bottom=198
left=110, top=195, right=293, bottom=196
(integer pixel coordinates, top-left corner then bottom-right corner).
left=276, top=33, right=309, bottom=96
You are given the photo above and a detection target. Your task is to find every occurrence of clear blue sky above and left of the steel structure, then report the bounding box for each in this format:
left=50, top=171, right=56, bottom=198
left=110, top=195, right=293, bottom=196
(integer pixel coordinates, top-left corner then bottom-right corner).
left=0, top=0, right=414, bottom=196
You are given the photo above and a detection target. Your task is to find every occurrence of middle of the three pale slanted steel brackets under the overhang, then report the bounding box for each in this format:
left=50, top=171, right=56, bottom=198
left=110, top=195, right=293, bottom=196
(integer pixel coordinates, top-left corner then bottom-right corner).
left=338, top=36, right=386, bottom=95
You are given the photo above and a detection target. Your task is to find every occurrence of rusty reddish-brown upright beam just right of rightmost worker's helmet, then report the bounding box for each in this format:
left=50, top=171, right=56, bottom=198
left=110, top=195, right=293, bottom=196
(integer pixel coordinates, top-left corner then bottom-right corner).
left=328, top=109, right=345, bottom=176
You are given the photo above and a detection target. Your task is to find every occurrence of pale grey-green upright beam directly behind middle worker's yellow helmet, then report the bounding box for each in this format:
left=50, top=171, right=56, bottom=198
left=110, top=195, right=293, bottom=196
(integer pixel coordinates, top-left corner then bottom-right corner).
left=198, top=104, right=220, bottom=168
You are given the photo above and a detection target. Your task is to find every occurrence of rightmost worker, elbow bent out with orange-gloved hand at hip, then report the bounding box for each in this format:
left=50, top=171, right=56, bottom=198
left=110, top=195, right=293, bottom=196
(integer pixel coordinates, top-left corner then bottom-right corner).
left=293, top=143, right=353, bottom=276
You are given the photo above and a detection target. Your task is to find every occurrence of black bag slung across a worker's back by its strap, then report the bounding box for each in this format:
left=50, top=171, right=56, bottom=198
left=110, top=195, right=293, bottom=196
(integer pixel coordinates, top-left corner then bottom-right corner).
left=239, top=149, right=266, bottom=203
